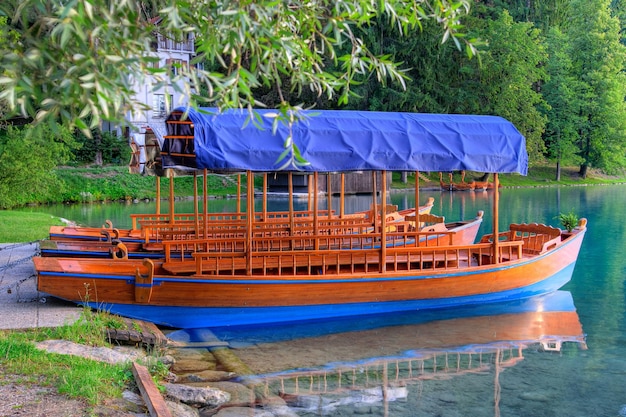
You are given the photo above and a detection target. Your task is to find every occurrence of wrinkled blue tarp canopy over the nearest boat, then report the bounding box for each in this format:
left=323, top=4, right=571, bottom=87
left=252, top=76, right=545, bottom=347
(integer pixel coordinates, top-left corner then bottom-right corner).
left=163, top=108, right=528, bottom=175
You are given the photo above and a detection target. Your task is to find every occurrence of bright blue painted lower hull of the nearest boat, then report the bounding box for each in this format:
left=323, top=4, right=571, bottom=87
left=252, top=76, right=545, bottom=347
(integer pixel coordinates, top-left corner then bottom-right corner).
left=89, top=263, right=575, bottom=329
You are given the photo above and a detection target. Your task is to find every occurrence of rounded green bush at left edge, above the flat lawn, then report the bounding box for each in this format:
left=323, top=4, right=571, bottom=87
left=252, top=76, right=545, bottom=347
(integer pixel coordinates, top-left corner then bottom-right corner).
left=0, top=125, right=76, bottom=208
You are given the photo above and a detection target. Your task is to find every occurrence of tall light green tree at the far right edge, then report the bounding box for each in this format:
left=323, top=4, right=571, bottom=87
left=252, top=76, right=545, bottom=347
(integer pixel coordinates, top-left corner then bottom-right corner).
left=564, top=0, right=626, bottom=176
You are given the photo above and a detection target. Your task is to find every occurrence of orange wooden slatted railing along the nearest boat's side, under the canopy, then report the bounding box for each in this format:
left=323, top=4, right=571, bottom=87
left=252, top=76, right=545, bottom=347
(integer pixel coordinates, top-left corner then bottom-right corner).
left=163, top=236, right=523, bottom=276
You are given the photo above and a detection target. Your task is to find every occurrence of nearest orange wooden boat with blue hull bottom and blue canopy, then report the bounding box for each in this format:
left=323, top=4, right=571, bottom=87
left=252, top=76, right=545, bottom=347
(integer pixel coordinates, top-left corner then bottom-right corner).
left=34, top=109, right=586, bottom=328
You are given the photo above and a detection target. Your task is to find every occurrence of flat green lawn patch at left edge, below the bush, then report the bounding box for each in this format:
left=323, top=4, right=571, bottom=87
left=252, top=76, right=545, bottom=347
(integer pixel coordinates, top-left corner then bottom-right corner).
left=0, top=210, right=63, bottom=243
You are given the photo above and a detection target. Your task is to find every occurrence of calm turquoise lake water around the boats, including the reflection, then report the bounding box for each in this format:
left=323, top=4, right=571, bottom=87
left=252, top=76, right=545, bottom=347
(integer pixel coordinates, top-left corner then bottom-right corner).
left=18, top=185, right=626, bottom=417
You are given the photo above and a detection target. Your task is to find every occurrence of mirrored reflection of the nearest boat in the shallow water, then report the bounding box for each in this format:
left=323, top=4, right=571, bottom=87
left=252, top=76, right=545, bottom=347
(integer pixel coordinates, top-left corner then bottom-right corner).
left=169, top=291, right=586, bottom=416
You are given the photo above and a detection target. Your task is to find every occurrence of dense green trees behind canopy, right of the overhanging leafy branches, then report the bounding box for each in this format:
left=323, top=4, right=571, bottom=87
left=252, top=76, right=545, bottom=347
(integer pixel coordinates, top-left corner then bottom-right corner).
left=322, top=0, right=626, bottom=180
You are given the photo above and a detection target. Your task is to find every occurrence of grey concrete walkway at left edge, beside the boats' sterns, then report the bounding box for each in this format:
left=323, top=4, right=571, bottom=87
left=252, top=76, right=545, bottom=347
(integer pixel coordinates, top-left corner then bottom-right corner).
left=0, top=242, right=81, bottom=329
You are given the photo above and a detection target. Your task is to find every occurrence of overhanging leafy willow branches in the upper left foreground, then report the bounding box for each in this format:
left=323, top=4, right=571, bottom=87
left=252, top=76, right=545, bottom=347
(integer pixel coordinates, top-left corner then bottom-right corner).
left=0, top=0, right=473, bottom=153
